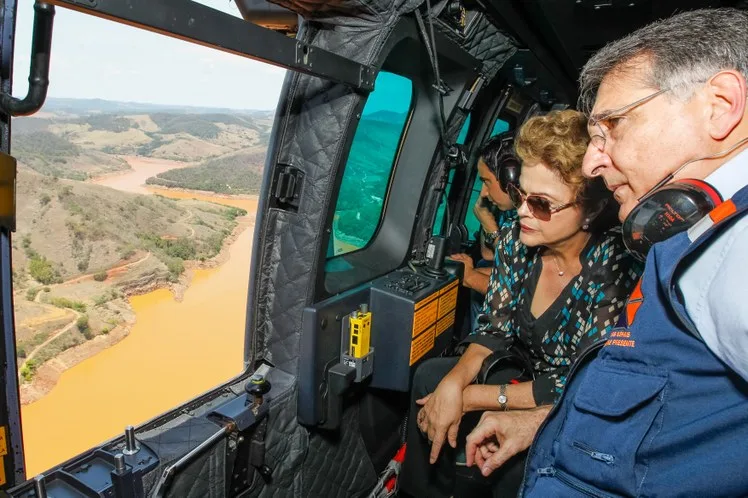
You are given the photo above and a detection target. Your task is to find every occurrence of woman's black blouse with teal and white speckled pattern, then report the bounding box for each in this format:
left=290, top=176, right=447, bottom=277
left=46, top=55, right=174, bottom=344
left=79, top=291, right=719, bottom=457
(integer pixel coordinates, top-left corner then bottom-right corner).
left=465, top=219, right=642, bottom=405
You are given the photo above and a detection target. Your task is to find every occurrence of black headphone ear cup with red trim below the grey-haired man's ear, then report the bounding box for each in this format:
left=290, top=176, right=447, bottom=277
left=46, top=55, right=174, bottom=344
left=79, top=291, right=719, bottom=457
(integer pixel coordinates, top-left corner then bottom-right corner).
left=623, top=179, right=722, bottom=261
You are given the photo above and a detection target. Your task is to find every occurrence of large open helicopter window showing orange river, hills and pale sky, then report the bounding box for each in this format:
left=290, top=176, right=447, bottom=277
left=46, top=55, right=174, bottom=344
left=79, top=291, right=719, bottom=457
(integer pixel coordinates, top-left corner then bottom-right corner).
left=11, top=0, right=285, bottom=474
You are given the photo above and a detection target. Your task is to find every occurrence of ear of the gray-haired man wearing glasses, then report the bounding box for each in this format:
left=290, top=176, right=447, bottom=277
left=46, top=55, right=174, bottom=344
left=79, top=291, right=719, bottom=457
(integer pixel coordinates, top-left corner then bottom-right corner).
left=706, top=70, right=747, bottom=140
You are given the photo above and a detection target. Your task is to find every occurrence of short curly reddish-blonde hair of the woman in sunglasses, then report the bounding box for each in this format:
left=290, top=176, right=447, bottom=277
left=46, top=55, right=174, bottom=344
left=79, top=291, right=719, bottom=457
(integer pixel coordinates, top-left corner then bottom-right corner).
left=514, top=110, right=590, bottom=197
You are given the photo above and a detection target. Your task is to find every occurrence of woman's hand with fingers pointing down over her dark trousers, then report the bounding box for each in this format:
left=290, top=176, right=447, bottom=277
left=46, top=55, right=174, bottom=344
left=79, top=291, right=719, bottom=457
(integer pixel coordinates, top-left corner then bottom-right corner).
left=416, top=376, right=463, bottom=464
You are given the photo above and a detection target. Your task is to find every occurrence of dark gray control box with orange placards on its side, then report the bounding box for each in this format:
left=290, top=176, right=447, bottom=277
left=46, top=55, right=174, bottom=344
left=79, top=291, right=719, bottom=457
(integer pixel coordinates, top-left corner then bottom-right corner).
left=370, top=269, right=459, bottom=391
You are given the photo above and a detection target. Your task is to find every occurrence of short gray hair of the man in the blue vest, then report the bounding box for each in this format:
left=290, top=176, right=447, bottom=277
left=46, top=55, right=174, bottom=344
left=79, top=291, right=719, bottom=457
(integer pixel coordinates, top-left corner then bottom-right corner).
left=579, top=8, right=748, bottom=114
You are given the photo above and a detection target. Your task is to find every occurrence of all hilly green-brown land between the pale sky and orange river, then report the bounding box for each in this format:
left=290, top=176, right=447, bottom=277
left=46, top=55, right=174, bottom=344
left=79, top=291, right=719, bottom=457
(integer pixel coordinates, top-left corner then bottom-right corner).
left=12, top=99, right=272, bottom=403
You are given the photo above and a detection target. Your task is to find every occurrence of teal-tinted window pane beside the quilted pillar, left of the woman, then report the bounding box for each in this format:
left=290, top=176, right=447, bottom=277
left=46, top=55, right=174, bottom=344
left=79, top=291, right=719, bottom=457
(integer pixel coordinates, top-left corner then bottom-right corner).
left=328, top=71, right=413, bottom=257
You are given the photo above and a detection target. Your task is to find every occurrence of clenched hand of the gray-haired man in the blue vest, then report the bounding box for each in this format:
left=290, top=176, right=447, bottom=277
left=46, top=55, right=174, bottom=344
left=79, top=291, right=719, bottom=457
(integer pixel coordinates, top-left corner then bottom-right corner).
left=466, top=406, right=551, bottom=476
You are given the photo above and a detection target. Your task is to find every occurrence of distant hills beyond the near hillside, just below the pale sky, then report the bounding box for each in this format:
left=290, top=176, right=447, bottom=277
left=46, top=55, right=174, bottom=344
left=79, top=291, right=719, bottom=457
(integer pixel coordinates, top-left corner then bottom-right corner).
left=11, top=98, right=275, bottom=183
